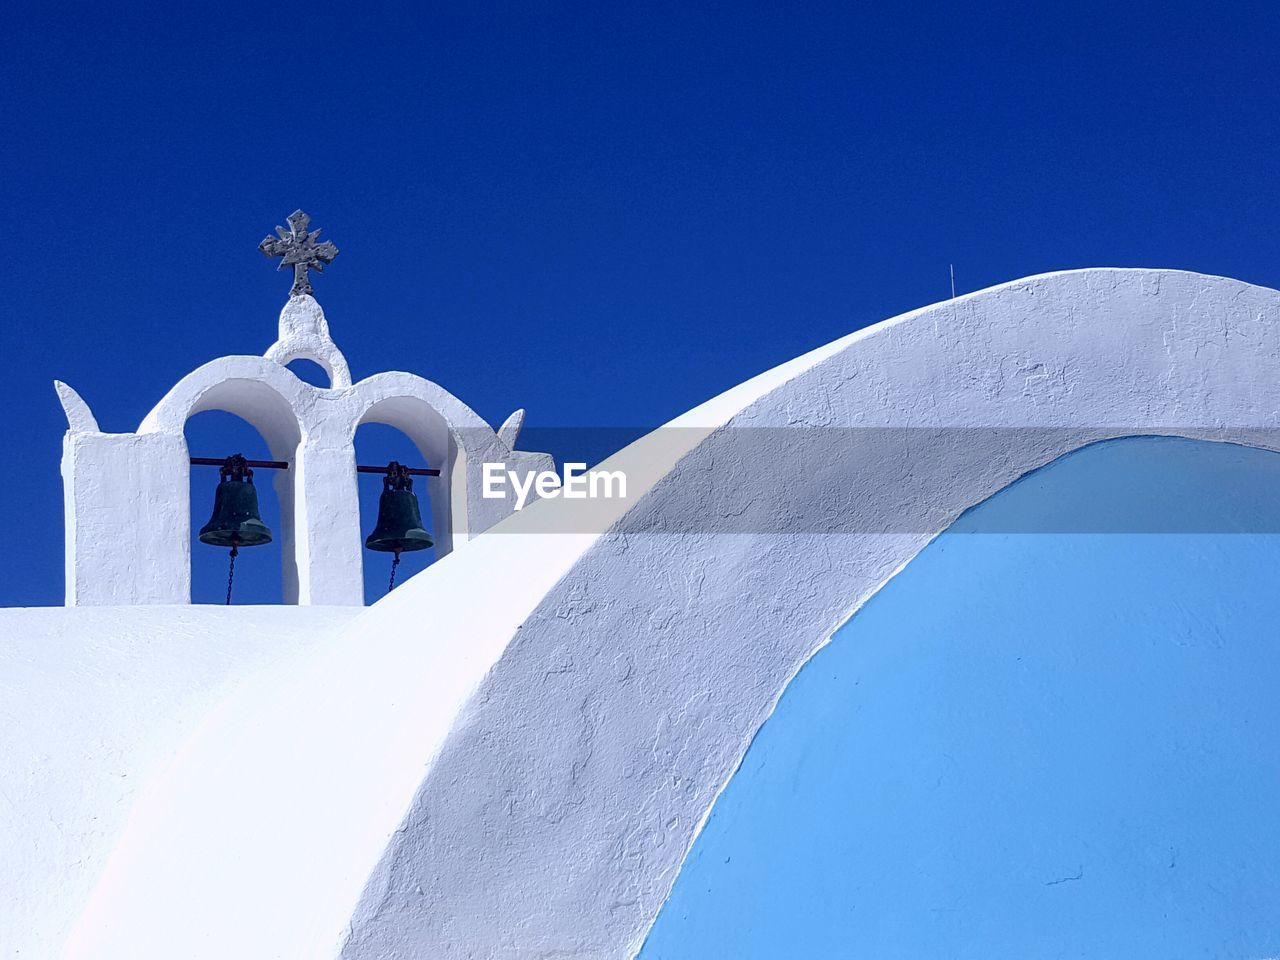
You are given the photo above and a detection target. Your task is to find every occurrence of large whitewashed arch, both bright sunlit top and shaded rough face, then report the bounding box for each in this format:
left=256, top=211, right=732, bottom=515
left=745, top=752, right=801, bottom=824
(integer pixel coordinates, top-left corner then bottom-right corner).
left=35, top=270, right=1280, bottom=960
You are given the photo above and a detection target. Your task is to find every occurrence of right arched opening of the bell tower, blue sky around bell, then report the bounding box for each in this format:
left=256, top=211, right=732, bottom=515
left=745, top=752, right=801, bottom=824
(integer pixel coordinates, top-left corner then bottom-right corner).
left=356, top=422, right=440, bottom=603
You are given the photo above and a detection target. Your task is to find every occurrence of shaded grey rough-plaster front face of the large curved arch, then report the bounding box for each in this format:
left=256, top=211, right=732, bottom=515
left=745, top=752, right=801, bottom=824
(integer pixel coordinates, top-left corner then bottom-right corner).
left=343, top=270, right=1280, bottom=960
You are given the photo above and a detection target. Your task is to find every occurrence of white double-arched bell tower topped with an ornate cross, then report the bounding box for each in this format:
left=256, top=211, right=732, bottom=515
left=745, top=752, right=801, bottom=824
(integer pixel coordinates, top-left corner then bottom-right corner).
left=55, top=211, right=554, bottom=605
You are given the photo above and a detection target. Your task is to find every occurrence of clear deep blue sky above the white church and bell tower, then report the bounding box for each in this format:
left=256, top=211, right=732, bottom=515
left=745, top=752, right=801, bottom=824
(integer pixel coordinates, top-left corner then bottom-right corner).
left=0, top=3, right=1280, bottom=604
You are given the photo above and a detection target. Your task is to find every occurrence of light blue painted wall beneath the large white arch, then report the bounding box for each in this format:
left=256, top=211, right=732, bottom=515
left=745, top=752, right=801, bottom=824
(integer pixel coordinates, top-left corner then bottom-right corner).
left=640, top=438, right=1280, bottom=960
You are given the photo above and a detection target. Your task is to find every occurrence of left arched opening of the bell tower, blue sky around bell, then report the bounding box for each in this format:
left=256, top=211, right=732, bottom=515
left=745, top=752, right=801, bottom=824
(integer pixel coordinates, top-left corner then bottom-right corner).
left=184, top=410, right=292, bottom=604
